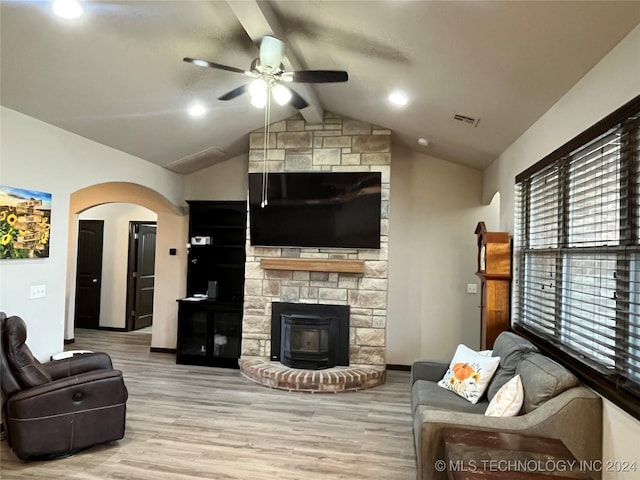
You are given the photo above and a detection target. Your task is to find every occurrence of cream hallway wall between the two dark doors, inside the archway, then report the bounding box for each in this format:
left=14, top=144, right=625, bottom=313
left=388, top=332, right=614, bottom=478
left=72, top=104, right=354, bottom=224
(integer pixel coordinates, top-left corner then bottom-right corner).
left=80, top=203, right=158, bottom=328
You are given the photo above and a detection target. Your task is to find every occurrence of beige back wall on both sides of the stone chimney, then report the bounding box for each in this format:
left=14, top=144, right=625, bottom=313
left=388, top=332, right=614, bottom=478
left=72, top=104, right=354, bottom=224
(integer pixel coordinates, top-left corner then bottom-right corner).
left=185, top=147, right=498, bottom=365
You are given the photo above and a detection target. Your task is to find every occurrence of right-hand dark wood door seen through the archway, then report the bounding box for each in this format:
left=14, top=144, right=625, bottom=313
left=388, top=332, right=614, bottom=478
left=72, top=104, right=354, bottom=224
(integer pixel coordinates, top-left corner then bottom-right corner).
left=132, top=223, right=156, bottom=330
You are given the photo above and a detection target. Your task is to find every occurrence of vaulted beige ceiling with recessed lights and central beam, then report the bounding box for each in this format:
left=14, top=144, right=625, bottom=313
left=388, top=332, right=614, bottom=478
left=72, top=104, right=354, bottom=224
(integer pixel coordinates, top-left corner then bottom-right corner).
left=0, top=0, right=640, bottom=173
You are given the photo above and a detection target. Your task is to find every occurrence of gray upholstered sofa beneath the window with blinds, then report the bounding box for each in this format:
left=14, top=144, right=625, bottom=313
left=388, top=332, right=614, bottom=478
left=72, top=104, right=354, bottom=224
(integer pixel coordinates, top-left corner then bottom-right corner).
left=411, top=332, right=602, bottom=480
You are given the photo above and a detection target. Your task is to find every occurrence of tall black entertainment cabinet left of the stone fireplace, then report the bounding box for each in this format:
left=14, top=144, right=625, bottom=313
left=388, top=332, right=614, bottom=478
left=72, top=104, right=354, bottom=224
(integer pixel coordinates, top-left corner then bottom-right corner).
left=176, top=201, right=247, bottom=368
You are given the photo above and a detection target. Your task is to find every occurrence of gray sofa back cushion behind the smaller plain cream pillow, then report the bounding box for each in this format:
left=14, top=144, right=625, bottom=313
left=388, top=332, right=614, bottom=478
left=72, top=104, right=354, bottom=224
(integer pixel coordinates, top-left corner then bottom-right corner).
left=516, top=353, right=578, bottom=413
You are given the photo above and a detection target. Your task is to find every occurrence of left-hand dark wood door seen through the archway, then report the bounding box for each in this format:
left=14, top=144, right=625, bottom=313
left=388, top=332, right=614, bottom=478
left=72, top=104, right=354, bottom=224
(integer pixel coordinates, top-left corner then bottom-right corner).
left=75, top=220, right=104, bottom=328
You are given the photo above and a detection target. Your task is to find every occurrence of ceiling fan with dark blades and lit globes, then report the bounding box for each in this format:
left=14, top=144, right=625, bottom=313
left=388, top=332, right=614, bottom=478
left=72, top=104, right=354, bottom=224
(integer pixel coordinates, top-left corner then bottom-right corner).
left=183, top=35, right=349, bottom=110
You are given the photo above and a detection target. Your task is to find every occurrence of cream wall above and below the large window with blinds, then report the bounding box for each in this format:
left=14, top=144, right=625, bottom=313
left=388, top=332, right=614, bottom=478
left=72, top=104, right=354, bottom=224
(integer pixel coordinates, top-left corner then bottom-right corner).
left=483, top=26, right=640, bottom=480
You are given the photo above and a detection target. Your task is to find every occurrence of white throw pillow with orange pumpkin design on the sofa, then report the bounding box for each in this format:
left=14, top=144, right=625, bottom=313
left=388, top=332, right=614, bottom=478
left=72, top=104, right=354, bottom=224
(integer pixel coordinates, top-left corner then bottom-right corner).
left=438, top=344, right=500, bottom=403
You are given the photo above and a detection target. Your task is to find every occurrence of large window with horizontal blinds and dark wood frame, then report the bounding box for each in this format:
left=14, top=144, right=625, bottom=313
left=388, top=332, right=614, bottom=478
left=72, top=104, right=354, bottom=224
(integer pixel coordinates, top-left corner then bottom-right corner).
left=514, top=97, right=640, bottom=418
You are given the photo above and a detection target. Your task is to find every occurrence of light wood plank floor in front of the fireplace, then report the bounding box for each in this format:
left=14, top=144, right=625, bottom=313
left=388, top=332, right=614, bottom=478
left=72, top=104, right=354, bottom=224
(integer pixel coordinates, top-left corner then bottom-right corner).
left=0, top=330, right=415, bottom=480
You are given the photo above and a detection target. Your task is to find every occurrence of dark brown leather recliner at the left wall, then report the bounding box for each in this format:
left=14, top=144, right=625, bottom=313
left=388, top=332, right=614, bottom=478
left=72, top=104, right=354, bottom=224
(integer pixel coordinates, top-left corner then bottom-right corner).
left=0, top=313, right=128, bottom=459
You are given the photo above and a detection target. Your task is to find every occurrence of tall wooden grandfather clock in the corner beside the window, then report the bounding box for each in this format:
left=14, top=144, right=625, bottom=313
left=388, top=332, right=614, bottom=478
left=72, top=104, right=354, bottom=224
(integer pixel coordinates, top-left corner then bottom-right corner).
left=475, top=222, right=511, bottom=350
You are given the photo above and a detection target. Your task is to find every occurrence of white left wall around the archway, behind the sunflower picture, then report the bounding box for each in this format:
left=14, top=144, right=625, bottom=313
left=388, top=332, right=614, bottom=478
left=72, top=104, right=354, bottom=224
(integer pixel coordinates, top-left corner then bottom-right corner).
left=0, top=107, right=184, bottom=360
